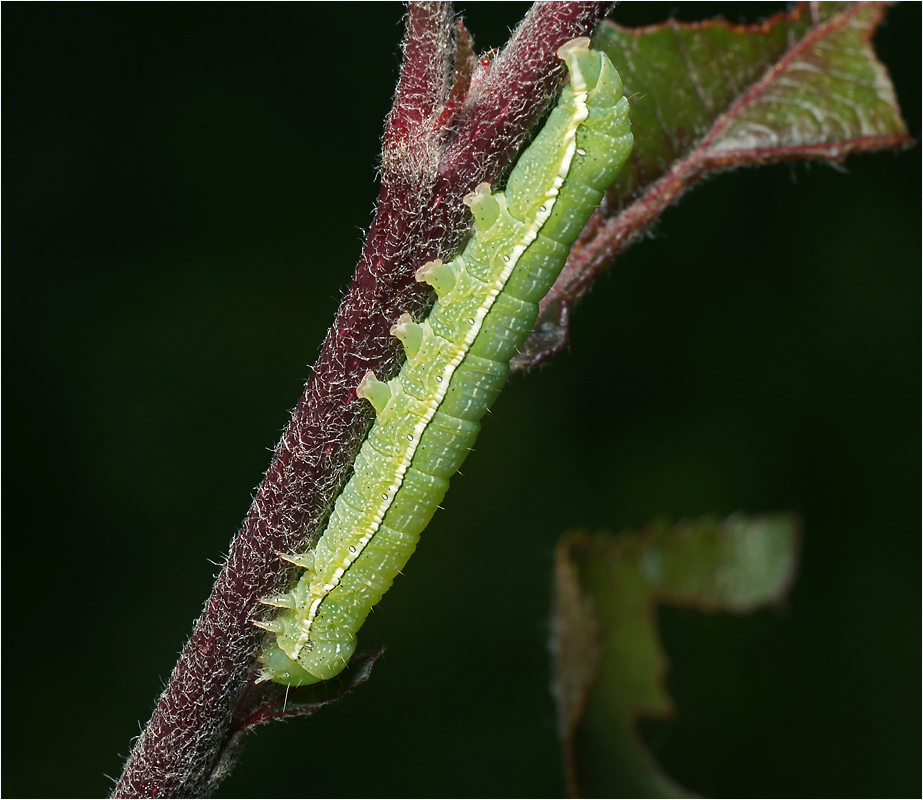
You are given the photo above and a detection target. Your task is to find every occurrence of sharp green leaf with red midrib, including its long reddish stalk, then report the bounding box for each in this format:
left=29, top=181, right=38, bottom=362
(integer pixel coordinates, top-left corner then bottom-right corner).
left=514, top=3, right=913, bottom=368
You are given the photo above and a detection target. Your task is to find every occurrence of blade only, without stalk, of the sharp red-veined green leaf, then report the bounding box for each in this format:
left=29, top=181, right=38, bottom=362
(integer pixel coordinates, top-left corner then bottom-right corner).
left=594, top=3, right=907, bottom=199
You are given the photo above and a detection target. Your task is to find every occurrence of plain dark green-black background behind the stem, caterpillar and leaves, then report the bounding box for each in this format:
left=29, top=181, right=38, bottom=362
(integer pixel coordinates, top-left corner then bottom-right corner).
left=2, top=3, right=921, bottom=797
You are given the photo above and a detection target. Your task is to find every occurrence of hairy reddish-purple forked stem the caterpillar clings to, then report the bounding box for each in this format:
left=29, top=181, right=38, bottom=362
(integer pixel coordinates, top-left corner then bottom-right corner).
left=114, top=2, right=612, bottom=797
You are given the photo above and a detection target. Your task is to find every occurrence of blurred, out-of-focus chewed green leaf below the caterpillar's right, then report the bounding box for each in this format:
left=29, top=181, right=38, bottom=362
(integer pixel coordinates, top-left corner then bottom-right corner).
left=552, top=515, right=798, bottom=797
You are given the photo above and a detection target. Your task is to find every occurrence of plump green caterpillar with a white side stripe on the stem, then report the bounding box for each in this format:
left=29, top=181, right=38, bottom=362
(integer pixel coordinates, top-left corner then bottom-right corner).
left=255, top=38, right=632, bottom=686
